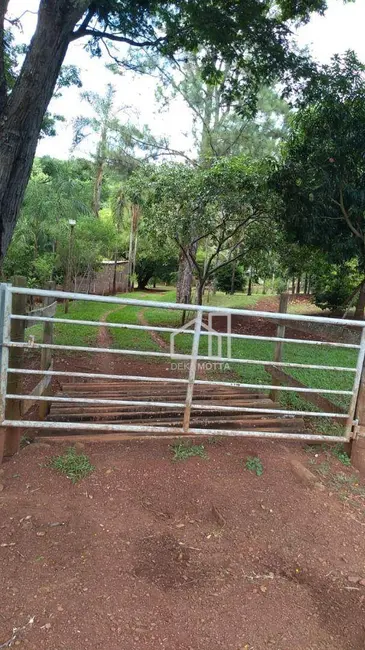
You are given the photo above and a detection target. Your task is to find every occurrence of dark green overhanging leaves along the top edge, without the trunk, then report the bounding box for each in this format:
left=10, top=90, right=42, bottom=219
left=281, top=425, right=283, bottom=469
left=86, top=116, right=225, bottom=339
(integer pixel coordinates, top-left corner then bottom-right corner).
left=84, top=0, right=327, bottom=115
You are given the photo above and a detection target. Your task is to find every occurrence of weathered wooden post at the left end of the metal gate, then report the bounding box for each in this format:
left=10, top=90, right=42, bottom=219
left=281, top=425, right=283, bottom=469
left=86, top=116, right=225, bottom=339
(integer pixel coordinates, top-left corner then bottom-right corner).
left=4, top=275, right=27, bottom=456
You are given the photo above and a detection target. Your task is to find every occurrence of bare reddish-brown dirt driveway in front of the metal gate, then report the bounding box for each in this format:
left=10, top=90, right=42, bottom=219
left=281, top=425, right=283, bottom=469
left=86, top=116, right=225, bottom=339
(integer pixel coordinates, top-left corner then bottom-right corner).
left=0, top=440, right=365, bottom=650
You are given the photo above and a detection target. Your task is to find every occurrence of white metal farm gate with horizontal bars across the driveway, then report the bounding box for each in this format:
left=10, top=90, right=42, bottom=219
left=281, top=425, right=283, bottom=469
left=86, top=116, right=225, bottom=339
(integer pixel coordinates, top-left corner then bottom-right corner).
left=0, top=284, right=365, bottom=442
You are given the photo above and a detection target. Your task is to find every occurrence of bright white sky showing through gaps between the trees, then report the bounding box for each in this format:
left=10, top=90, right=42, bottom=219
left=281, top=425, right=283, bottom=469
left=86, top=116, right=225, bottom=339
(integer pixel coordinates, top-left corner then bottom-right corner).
left=9, top=0, right=365, bottom=158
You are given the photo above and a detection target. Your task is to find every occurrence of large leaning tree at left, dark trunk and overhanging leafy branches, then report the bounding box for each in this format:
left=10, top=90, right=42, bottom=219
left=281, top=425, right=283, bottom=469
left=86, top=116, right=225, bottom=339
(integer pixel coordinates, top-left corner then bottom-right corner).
left=0, top=0, right=326, bottom=260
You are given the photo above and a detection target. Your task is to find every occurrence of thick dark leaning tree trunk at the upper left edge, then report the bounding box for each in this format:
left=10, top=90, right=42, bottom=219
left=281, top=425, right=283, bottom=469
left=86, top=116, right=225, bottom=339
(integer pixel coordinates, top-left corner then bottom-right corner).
left=0, top=0, right=86, bottom=261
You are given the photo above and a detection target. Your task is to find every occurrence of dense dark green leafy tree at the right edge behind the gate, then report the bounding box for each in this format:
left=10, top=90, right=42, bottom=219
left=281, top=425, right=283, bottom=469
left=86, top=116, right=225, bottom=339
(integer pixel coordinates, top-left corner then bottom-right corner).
left=274, top=52, right=365, bottom=317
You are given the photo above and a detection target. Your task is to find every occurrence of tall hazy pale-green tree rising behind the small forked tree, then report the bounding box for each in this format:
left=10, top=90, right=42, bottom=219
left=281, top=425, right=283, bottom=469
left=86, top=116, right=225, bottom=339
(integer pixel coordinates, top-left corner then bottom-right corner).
left=125, top=52, right=289, bottom=302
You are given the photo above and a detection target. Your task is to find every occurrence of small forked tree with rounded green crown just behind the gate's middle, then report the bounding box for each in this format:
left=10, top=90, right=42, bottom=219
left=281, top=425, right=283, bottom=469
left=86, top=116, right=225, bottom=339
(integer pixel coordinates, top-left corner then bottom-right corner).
left=130, top=158, right=273, bottom=304
